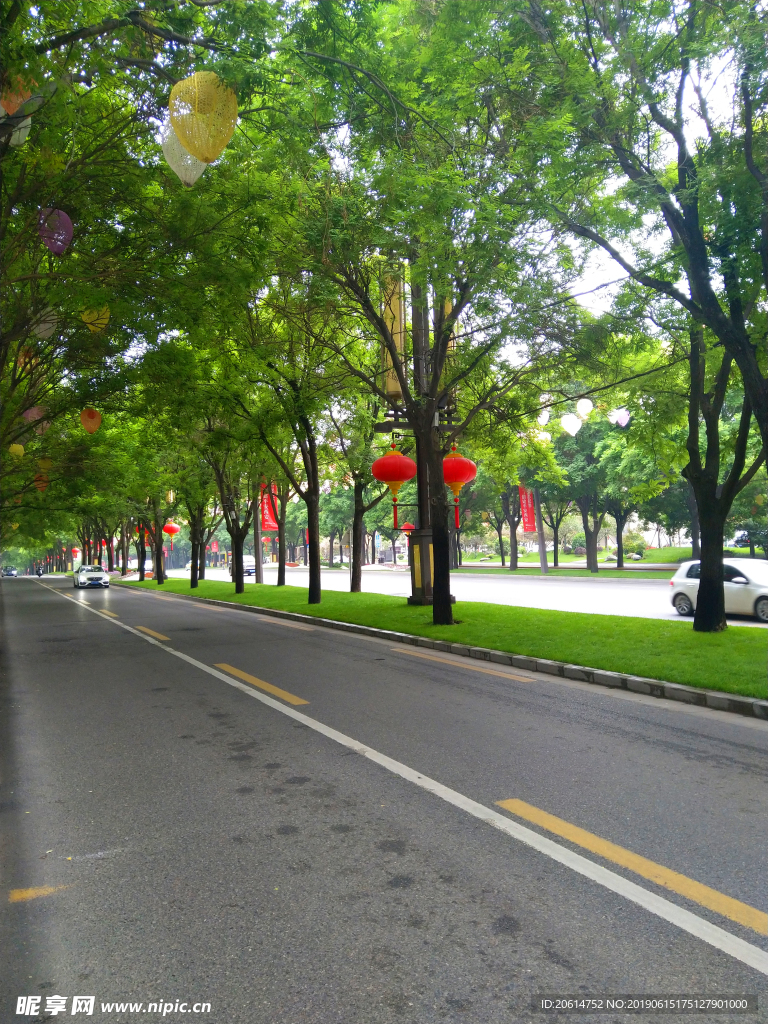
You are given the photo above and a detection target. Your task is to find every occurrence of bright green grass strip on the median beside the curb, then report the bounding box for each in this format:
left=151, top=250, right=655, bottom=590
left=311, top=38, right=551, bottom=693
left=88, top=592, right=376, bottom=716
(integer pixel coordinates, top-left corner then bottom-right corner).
left=123, top=580, right=768, bottom=698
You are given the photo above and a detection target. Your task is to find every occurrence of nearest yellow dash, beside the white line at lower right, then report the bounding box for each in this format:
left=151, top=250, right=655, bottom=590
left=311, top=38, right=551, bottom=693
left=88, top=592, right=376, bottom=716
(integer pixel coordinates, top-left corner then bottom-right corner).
left=497, top=800, right=768, bottom=935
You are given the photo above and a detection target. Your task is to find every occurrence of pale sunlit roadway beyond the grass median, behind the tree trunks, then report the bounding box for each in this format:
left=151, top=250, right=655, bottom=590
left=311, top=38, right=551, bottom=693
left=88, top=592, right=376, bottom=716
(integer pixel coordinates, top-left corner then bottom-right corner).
left=169, top=565, right=766, bottom=629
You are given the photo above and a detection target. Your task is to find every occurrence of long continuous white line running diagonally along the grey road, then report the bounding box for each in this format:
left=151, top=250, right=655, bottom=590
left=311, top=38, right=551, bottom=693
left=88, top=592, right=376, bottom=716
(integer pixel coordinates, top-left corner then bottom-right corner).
left=34, top=583, right=768, bottom=975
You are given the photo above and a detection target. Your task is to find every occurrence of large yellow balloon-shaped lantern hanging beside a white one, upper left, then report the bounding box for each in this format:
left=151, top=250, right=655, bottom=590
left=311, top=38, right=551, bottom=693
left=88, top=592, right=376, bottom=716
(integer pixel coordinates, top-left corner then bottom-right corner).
left=168, top=71, right=238, bottom=164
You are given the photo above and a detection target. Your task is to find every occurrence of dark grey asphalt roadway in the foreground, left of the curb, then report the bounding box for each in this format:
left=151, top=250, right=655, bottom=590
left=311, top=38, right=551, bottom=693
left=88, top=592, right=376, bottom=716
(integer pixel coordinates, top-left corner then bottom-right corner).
left=0, top=579, right=768, bottom=1024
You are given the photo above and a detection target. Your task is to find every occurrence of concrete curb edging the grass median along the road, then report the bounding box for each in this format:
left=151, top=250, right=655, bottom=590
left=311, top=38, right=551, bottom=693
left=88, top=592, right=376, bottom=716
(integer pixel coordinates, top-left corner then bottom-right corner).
left=117, top=587, right=768, bottom=721
